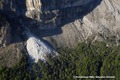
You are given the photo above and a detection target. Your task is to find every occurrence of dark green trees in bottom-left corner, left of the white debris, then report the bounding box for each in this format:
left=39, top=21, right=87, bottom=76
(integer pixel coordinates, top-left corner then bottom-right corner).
left=0, top=52, right=32, bottom=80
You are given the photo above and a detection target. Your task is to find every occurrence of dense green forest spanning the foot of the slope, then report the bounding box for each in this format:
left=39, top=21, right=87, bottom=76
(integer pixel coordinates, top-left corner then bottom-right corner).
left=0, top=42, right=120, bottom=80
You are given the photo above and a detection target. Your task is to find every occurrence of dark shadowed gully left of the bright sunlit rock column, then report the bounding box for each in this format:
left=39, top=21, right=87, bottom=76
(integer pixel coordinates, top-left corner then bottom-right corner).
left=0, top=0, right=27, bottom=43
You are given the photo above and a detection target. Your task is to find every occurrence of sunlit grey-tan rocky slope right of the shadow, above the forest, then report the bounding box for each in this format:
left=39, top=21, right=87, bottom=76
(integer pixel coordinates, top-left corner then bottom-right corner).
left=39, top=0, right=120, bottom=47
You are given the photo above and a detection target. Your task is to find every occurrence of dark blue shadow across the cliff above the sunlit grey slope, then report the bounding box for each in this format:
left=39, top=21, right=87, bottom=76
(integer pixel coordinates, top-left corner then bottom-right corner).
left=29, top=0, right=102, bottom=37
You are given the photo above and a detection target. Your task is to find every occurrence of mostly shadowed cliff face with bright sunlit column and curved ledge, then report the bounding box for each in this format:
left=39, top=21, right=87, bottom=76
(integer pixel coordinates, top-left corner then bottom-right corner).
left=26, top=0, right=96, bottom=29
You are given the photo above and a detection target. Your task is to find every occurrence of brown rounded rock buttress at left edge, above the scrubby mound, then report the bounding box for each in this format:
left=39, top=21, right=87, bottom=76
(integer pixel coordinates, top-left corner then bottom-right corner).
left=0, top=14, right=11, bottom=47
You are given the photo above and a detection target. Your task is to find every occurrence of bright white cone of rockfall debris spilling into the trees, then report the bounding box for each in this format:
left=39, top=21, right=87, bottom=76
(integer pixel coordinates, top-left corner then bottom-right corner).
left=26, top=29, right=58, bottom=63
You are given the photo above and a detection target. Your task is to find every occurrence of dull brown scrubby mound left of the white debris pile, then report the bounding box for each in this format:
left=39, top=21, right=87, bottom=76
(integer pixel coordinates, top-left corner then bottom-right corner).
left=0, top=43, right=25, bottom=67
